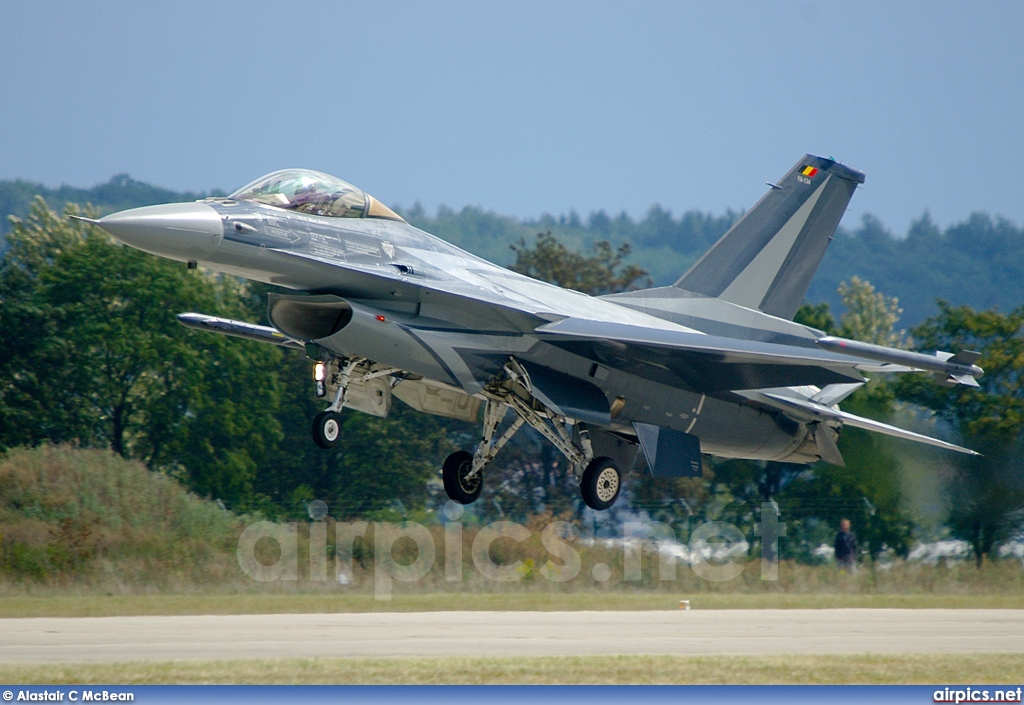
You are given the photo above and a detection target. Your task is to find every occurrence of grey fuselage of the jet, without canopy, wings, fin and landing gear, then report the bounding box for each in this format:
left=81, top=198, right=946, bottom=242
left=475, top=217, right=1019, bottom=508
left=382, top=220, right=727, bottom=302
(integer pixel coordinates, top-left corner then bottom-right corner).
left=96, top=191, right=817, bottom=462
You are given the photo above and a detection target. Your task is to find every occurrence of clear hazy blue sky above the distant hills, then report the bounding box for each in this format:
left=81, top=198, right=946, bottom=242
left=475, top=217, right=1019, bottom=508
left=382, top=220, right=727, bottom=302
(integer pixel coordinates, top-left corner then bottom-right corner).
left=0, top=0, right=1024, bottom=233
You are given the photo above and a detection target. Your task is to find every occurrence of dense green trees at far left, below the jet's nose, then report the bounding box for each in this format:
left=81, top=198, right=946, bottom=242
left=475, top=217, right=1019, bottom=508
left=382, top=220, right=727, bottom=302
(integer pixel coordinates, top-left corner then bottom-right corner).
left=0, top=200, right=281, bottom=505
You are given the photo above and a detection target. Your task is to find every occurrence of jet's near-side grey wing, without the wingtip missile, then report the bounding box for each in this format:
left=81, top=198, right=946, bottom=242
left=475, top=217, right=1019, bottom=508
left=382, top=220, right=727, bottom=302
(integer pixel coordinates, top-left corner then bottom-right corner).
left=534, top=318, right=877, bottom=393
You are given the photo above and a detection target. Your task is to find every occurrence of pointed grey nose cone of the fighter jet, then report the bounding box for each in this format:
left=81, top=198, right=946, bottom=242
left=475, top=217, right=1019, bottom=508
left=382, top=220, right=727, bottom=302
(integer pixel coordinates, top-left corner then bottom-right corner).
left=96, top=203, right=224, bottom=261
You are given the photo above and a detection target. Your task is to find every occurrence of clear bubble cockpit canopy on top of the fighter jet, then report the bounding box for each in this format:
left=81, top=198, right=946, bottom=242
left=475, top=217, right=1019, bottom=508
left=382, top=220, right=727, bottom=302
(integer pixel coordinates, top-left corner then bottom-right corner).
left=228, top=169, right=401, bottom=220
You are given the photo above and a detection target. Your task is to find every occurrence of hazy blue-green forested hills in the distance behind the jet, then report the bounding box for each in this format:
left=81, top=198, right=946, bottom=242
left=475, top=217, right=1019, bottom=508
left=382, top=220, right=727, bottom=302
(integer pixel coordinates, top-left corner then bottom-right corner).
left=0, top=174, right=1024, bottom=326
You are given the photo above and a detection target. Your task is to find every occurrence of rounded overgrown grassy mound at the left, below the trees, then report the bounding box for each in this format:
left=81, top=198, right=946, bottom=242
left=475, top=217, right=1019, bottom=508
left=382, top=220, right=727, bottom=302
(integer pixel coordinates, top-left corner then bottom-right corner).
left=0, top=446, right=247, bottom=591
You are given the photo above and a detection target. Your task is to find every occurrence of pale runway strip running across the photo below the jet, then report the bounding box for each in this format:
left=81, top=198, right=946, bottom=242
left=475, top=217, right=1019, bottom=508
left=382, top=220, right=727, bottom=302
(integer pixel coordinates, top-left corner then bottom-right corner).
left=0, top=609, right=1024, bottom=663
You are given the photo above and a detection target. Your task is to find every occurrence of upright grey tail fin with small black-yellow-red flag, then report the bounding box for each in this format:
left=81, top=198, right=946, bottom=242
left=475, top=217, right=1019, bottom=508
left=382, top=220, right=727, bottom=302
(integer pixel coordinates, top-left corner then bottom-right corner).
left=675, top=155, right=864, bottom=320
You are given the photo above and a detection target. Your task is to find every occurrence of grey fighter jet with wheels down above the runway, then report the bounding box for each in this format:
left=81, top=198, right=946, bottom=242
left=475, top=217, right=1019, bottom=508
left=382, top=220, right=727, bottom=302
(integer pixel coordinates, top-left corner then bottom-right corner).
left=75, top=155, right=982, bottom=510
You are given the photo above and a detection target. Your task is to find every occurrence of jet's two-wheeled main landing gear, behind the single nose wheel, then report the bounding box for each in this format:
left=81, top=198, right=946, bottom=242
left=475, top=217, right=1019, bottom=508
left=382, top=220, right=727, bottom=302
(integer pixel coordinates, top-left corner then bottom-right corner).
left=441, top=360, right=623, bottom=510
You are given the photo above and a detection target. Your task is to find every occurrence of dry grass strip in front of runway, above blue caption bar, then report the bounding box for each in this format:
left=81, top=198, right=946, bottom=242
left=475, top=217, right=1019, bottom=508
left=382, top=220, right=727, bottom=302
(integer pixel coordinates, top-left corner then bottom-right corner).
left=0, top=654, right=1024, bottom=685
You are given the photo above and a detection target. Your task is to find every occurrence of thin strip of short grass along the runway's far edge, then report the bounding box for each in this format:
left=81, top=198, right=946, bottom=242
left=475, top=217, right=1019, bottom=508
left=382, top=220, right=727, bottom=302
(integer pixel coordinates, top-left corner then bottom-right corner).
left=0, top=592, right=1024, bottom=618
